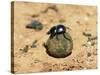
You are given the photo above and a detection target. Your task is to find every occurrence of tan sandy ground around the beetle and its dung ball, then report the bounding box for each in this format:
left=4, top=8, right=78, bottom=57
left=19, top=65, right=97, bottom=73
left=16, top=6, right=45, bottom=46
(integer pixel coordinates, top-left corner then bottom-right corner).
left=12, top=2, right=97, bottom=73
